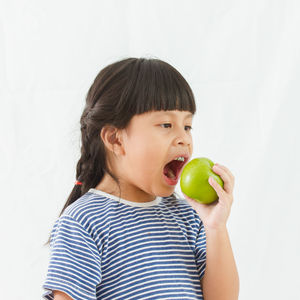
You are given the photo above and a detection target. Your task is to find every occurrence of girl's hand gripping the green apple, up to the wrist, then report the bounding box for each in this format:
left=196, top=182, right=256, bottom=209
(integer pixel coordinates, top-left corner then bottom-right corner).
left=183, top=164, right=234, bottom=229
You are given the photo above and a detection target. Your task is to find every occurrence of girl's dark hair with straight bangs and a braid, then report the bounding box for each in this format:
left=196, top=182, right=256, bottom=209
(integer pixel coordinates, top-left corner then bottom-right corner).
left=45, top=57, right=196, bottom=245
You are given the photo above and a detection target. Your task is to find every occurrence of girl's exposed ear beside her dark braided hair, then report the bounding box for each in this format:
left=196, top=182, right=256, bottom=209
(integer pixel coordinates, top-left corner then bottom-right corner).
left=100, top=125, right=125, bottom=155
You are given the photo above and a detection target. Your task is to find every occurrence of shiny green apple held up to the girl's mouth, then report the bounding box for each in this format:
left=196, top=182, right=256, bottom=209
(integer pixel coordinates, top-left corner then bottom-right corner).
left=180, top=157, right=224, bottom=204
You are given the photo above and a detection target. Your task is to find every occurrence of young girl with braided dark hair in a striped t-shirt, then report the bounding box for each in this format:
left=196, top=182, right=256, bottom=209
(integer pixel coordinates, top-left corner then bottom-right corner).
left=43, top=58, right=239, bottom=300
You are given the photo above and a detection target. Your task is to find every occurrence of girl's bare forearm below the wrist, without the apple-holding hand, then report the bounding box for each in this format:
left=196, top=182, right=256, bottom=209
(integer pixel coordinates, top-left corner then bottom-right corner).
left=201, top=227, right=239, bottom=300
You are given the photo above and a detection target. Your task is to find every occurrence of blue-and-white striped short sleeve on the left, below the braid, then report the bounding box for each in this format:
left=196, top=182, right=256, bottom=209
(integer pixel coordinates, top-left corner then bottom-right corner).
left=43, top=215, right=102, bottom=300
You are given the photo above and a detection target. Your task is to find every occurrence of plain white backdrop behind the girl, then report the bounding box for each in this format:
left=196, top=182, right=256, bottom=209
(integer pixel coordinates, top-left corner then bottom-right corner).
left=0, top=0, right=300, bottom=300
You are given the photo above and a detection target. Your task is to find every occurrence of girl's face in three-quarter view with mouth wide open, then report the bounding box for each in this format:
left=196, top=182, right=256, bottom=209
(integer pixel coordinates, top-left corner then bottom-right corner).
left=117, top=110, right=193, bottom=198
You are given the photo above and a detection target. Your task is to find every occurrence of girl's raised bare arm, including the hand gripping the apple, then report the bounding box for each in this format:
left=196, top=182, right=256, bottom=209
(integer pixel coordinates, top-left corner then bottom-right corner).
left=185, top=164, right=239, bottom=300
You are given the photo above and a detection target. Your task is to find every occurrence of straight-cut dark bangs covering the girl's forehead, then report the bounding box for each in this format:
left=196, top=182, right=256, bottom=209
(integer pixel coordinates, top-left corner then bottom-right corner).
left=128, top=59, right=196, bottom=114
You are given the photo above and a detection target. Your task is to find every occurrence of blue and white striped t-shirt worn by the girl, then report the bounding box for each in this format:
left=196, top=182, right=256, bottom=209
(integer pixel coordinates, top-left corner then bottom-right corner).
left=43, top=188, right=206, bottom=300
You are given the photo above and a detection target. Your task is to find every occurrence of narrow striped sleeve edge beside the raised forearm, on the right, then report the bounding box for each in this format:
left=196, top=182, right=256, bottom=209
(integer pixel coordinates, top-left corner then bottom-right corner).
left=195, top=218, right=206, bottom=280
